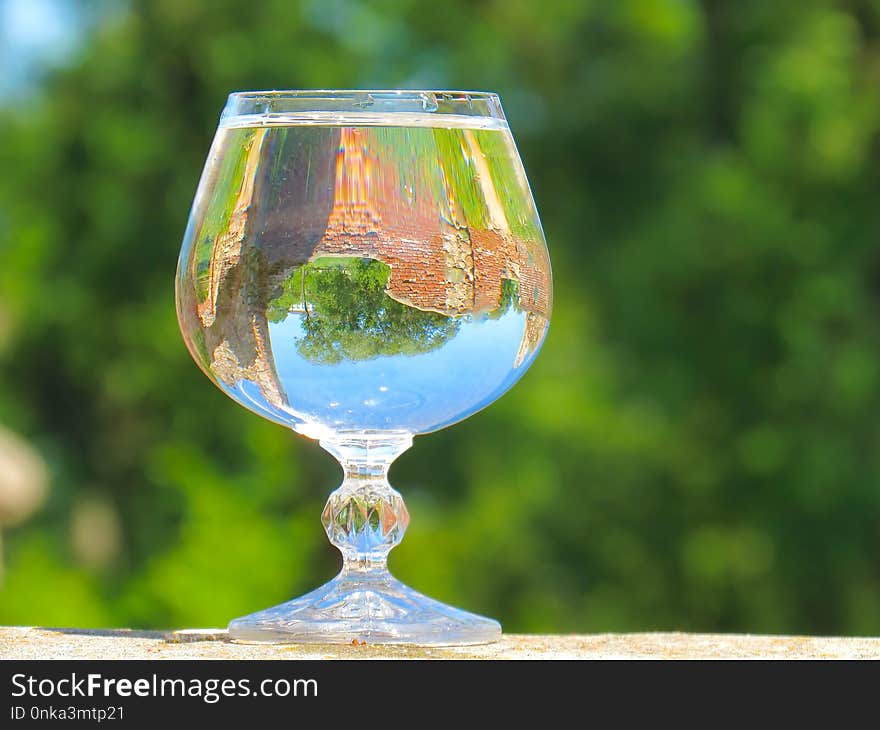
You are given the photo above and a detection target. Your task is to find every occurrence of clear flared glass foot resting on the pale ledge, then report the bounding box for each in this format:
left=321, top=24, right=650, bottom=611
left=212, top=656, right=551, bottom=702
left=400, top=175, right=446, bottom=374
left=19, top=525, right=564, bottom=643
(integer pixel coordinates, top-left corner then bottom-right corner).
left=229, top=571, right=501, bottom=646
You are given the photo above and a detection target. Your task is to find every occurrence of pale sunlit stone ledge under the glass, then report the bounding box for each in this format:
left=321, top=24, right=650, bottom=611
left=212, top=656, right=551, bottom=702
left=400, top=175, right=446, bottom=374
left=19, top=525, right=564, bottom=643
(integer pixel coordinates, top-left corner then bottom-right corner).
left=0, top=627, right=880, bottom=659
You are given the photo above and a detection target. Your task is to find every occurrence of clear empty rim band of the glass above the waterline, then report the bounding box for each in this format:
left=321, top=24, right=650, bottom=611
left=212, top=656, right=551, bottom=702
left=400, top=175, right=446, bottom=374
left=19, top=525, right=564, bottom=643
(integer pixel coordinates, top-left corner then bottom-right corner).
left=222, top=89, right=506, bottom=123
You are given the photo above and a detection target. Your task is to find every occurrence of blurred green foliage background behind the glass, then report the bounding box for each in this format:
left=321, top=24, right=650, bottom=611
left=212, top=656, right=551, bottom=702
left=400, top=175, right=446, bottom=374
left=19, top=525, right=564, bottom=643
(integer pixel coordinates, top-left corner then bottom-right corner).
left=0, top=0, right=880, bottom=634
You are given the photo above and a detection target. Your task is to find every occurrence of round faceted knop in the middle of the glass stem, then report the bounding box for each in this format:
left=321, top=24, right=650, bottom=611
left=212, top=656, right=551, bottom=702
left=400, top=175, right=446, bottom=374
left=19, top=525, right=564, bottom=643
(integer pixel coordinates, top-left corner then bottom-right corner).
left=321, top=479, right=409, bottom=561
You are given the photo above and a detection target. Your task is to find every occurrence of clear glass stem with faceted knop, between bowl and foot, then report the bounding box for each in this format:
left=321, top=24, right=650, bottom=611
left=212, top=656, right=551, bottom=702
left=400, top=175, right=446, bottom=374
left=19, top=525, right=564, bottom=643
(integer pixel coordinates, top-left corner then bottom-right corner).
left=320, top=433, right=412, bottom=575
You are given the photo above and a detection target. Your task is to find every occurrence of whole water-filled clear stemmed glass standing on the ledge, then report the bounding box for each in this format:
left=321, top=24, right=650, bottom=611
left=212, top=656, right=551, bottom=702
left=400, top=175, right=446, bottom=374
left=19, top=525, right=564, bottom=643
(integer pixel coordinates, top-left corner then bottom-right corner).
left=176, top=91, right=552, bottom=645
